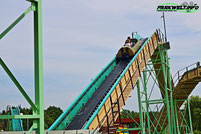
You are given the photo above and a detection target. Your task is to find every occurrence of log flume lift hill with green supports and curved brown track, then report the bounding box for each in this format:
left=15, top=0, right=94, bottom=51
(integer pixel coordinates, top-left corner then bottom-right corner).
left=49, top=30, right=201, bottom=134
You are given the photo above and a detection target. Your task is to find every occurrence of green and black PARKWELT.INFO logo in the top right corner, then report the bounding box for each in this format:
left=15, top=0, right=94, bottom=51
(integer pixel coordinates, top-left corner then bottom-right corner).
left=156, top=2, right=199, bottom=13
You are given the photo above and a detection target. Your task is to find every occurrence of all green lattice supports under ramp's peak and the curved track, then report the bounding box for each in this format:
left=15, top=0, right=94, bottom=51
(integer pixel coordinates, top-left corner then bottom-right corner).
left=122, top=45, right=193, bottom=134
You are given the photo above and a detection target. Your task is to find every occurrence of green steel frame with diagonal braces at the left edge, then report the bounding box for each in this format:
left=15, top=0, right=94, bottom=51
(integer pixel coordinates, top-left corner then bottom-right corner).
left=0, top=0, right=44, bottom=134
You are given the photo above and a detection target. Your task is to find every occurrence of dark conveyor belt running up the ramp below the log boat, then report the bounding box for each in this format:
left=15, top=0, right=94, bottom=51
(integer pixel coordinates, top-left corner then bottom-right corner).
left=66, top=60, right=129, bottom=130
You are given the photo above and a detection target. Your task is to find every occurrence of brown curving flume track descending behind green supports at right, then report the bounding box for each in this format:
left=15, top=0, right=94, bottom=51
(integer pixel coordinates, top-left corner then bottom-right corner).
left=148, top=36, right=201, bottom=132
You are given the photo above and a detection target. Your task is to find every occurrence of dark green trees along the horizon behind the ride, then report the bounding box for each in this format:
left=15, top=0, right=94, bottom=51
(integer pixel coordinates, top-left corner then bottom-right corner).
left=0, top=96, right=201, bottom=134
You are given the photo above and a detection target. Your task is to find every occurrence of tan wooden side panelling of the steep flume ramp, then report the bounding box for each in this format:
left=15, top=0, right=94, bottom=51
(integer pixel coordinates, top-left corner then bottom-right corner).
left=90, top=34, right=160, bottom=128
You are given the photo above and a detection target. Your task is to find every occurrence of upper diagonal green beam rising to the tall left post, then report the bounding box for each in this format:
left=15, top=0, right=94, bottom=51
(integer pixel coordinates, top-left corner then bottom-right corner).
left=0, top=6, right=32, bottom=40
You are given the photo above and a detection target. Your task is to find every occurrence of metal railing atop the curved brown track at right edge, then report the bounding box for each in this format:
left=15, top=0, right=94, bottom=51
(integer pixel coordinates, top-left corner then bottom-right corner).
left=173, top=62, right=200, bottom=86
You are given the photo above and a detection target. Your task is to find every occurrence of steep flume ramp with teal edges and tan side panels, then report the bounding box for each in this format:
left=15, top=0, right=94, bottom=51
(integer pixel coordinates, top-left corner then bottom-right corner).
left=49, top=31, right=160, bottom=130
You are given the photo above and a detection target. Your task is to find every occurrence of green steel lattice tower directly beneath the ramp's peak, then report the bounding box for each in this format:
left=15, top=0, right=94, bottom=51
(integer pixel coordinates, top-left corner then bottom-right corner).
left=118, top=45, right=179, bottom=134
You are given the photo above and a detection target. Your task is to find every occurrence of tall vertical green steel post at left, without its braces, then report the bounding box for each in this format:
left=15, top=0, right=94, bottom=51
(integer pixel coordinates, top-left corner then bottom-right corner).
left=32, top=0, right=45, bottom=134
